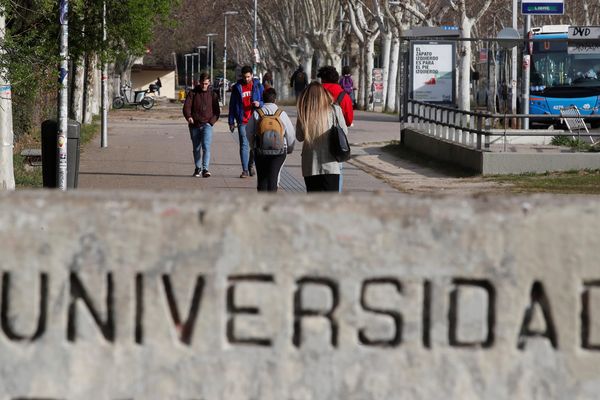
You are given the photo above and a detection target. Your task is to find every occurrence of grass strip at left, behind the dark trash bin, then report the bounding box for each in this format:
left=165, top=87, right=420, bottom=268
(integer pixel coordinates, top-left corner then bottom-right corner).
left=13, top=116, right=100, bottom=189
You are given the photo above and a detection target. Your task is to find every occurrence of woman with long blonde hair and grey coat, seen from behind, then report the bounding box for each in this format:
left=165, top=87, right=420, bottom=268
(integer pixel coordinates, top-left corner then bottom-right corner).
left=296, top=82, right=348, bottom=192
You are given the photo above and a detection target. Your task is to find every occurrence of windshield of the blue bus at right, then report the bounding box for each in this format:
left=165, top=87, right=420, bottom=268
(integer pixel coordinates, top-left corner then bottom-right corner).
left=531, top=38, right=600, bottom=92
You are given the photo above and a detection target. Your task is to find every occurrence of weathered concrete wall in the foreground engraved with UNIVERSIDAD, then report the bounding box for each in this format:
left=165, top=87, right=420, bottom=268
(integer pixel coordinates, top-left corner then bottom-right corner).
left=0, top=191, right=600, bottom=400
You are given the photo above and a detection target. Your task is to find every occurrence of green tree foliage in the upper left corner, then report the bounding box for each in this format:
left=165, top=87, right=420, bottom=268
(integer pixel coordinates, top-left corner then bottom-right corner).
left=0, top=0, right=179, bottom=140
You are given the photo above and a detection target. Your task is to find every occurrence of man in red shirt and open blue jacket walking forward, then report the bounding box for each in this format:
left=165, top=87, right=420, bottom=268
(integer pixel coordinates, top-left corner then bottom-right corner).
left=229, top=65, right=263, bottom=178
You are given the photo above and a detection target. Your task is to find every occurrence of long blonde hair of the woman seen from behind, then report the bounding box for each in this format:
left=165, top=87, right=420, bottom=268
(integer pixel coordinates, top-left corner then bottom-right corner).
left=297, top=82, right=332, bottom=145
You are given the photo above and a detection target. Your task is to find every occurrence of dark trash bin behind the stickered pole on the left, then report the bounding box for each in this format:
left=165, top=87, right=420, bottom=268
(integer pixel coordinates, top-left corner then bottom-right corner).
left=42, top=119, right=81, bottom=189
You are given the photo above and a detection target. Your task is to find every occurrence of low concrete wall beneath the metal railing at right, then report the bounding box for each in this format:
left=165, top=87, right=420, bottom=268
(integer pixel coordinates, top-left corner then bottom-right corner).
left=402, top=129, right=600, bottom=175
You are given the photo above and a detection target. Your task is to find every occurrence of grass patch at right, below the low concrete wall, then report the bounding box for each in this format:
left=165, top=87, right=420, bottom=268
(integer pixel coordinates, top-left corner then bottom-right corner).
left=483, top=170, right=600, bottom=194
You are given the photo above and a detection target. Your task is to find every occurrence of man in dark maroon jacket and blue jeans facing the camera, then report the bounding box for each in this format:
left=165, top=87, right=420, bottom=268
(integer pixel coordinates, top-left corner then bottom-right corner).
left=183, top=73, right=221, bottom=178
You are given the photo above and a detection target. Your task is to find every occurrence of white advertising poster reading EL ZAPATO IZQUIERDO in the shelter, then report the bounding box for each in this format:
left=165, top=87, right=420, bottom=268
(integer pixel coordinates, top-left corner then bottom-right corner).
left=411, top=43, right=455, bottom=103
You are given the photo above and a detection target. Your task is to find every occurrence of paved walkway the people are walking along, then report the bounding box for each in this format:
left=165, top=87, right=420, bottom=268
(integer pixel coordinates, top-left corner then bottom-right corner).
left=79, top=104, right=401, bottom=194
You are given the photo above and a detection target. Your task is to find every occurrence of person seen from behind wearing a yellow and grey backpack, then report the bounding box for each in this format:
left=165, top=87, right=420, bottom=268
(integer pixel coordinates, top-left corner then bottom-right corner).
left=246, top=88, right=296, bottom=192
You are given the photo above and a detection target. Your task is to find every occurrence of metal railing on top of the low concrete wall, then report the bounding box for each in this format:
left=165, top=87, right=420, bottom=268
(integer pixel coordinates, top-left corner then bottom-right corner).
left=404, top=100, right=600, bottom=150
